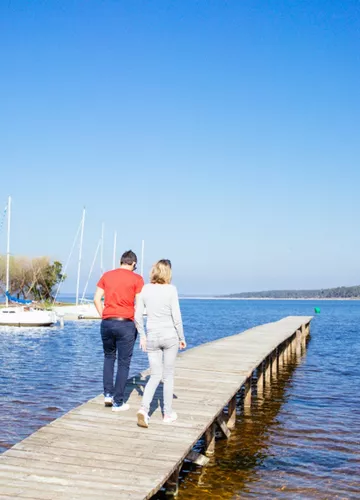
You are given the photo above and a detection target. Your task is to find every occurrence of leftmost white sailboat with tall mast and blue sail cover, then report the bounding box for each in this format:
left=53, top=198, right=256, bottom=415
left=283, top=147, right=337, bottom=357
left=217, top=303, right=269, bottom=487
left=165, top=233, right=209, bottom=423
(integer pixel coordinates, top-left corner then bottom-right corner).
left=0, top=196, right=58, bottom=327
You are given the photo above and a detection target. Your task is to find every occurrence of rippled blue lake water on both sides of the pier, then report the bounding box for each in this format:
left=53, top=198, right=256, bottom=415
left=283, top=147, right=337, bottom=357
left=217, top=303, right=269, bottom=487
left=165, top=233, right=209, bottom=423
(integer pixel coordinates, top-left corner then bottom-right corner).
left=0, top=299, right=360, bottom=500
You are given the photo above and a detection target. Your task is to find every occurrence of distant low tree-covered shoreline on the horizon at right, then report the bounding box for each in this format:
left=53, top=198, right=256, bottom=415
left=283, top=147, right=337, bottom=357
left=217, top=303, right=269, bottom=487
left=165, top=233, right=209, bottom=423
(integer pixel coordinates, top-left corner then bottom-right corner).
left=223, top=286, right=360, bottom=299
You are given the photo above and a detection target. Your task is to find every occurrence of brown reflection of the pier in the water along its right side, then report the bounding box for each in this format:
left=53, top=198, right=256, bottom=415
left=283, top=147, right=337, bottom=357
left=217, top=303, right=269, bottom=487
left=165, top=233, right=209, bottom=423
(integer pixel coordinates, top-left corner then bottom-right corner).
left=154, top=351, right=305, bottom=500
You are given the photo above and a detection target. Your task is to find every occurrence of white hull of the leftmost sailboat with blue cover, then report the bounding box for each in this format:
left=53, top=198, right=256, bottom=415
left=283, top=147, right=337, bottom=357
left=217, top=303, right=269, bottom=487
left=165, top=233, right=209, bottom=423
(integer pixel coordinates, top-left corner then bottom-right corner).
left=0, top=306, right=58, bottom=327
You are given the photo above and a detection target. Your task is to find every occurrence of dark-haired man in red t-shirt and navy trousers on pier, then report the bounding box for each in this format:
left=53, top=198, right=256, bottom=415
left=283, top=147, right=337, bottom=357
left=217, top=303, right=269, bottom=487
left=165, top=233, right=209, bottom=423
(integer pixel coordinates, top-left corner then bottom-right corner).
left=94, top=250, right=144, bottom=411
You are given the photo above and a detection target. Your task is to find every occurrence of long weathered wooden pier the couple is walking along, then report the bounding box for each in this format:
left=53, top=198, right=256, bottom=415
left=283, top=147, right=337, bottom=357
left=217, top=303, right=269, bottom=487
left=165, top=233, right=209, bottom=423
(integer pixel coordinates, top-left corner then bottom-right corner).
left=0, top=316, right=312, bottom=500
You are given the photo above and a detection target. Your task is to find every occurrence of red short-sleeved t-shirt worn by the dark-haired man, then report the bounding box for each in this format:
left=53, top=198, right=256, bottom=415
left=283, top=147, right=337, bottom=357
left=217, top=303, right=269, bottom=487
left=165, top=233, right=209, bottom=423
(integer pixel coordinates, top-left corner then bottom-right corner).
left=97, top=268, right=144, bottom=319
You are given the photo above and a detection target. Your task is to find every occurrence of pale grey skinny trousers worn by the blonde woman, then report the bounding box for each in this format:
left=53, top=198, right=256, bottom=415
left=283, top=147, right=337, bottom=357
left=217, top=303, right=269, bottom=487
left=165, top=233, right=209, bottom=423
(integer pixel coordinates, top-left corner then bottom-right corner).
left=141, top=334, right=179, bottom=415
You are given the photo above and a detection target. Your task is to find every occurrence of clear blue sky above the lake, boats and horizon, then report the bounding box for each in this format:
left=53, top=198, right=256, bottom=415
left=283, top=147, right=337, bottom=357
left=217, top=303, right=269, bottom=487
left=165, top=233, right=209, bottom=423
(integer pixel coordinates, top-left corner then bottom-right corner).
left=0, top=0, right=360, bottom=294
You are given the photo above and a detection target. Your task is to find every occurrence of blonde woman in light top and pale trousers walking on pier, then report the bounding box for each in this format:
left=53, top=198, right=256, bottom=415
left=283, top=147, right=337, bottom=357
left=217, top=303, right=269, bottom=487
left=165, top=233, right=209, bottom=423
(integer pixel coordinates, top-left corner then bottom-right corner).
left=135, top=259, right=186, bottom=427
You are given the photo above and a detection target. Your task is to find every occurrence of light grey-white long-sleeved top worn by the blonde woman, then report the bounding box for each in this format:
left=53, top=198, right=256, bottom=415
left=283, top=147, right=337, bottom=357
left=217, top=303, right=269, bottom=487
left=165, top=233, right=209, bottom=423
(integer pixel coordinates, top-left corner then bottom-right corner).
left=135, top=283, right=184, bottom=340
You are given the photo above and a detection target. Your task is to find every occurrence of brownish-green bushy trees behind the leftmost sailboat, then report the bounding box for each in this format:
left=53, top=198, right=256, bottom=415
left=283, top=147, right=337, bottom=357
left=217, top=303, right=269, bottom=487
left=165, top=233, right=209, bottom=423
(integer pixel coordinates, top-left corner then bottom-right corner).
left=0, top=255, right=66, bottom=301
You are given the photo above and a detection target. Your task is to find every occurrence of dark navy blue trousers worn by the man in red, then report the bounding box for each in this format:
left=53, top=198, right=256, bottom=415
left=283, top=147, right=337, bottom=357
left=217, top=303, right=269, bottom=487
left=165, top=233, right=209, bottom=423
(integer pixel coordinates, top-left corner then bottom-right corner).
left=100, top=319, right=137, bottom=404
